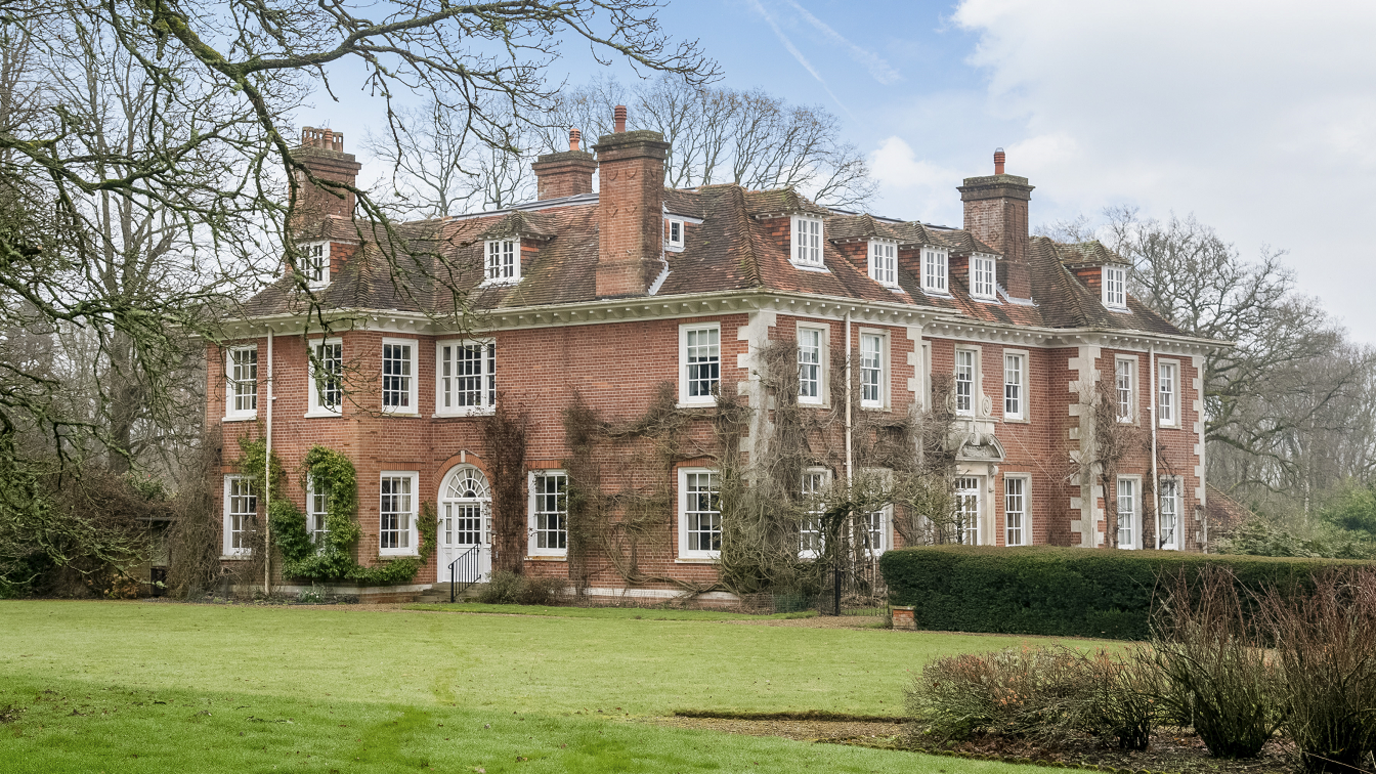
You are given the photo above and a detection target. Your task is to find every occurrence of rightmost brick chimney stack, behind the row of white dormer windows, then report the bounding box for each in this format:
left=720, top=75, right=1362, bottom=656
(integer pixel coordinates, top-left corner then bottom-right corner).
left=958, top=147, right=1033, bottom=299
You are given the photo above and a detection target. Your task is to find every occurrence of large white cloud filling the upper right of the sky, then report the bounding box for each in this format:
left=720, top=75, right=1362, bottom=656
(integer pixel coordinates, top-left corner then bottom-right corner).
left=952, top=0, right=1376, bottom=342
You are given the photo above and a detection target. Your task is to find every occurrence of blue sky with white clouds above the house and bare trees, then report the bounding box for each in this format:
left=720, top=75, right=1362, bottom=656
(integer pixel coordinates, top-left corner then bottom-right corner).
left=303, top=0, right=1376, bottom=337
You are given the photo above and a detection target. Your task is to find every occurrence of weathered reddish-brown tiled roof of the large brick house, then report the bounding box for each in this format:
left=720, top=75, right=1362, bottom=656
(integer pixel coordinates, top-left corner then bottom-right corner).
left=241, top=185, right=1179, bottom=333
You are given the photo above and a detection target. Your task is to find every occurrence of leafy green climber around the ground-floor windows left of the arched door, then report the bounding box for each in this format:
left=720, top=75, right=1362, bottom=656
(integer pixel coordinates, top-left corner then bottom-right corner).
left=238, top=439, right=438, bottom=585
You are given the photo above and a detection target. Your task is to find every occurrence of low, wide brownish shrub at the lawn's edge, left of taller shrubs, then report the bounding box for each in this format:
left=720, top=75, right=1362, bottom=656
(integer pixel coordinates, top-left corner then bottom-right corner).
left=908, top=647, right=1156, bottom=749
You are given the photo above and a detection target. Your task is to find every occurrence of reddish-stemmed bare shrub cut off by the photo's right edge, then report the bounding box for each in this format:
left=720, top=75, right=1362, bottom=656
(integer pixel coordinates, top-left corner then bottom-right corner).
left=1263, top=567, right=1376, bottom=771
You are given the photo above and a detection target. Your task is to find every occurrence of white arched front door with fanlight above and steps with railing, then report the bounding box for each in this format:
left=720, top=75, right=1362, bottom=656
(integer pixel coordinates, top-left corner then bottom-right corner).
left=439, top=464, right=493, bottom=583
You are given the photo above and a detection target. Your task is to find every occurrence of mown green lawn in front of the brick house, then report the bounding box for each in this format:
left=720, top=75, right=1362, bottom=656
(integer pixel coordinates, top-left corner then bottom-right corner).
left=0, top=602, right=1056, bottom=774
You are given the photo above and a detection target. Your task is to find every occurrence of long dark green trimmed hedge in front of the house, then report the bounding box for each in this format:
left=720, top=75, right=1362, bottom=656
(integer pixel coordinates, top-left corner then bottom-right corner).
left=879, top=545, right=1370, bottom=640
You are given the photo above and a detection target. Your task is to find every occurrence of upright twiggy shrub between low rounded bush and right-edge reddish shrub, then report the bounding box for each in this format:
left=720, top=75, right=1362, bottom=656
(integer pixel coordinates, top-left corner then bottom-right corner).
left=1152, top=567, right=1281, bottom=757
